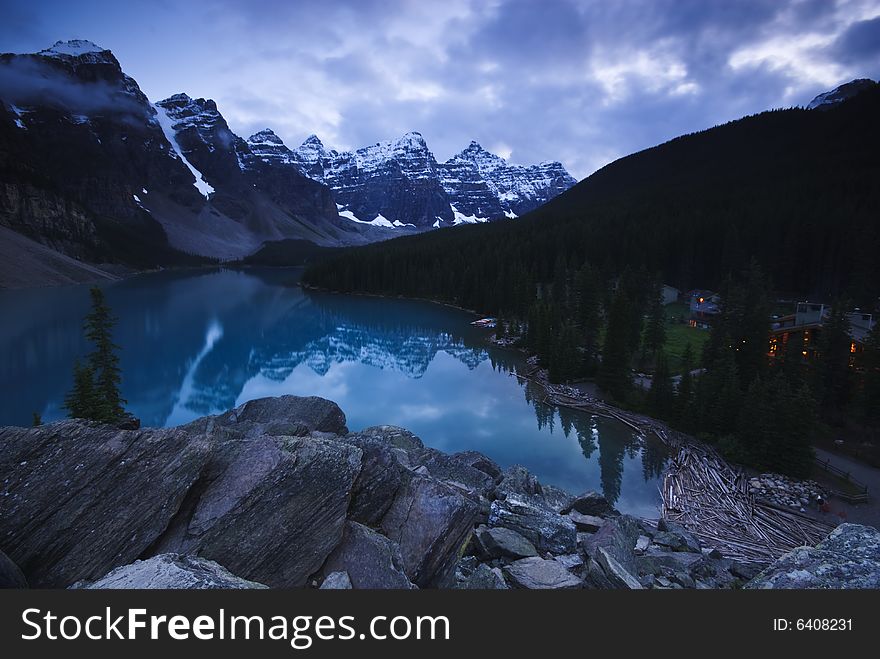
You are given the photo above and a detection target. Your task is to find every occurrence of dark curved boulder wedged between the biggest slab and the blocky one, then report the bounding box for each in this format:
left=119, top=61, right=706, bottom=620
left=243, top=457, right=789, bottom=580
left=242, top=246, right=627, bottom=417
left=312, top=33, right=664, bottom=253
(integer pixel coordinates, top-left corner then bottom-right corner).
left=341, top=433, right=401, bottom=526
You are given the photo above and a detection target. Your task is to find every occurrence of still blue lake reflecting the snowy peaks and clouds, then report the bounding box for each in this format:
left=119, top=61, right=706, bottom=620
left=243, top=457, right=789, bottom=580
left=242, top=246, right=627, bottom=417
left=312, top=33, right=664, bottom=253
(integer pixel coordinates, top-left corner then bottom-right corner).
left=0, top=269, right=665, bottom=517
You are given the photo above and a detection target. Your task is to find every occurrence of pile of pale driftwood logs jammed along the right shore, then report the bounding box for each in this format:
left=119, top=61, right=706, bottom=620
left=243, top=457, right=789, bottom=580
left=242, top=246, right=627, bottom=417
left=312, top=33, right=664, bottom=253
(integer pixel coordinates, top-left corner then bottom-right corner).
left=517, top=365, right=834, bottom=564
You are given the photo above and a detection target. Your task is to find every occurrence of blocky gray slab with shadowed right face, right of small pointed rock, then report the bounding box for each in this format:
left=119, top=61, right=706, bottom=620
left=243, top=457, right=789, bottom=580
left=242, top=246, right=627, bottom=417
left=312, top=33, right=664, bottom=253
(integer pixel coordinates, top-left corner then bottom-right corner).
left=381, top=475, right=479, bottom=588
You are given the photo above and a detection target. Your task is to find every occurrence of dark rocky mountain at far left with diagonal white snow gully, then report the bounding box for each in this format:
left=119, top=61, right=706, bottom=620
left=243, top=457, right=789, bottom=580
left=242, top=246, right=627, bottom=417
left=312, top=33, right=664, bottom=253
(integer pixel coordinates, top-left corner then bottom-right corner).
left=0, top=41, right=388, bottom=282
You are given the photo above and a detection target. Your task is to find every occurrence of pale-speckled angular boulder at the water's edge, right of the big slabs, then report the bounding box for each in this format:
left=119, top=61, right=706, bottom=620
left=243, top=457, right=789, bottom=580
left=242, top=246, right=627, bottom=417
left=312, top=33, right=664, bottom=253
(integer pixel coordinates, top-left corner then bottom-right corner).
left=489, top=494, right=577, bottom=554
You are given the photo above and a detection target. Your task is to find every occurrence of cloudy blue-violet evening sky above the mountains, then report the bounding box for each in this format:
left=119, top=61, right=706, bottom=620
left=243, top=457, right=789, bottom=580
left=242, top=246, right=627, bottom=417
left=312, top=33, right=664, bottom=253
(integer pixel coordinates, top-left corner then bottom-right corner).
left=0, top=0, right=880, bottom=178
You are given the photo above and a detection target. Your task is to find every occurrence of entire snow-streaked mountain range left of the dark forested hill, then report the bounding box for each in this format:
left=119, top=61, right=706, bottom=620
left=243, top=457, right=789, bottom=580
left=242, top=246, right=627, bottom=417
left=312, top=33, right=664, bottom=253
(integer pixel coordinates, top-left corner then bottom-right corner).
left=0, top=40, right=576, bottom=287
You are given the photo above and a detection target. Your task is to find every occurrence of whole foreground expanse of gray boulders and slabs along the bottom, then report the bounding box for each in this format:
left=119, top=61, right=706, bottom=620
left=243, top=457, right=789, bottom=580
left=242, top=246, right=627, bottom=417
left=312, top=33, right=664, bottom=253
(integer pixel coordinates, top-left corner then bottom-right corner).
left=0, top=396, right=878, bottom=589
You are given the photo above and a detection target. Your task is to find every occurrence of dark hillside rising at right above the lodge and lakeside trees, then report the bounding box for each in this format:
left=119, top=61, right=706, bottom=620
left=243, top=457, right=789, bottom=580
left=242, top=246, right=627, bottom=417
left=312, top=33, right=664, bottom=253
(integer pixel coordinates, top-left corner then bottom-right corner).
left=303, top=81, right=880, bottom=310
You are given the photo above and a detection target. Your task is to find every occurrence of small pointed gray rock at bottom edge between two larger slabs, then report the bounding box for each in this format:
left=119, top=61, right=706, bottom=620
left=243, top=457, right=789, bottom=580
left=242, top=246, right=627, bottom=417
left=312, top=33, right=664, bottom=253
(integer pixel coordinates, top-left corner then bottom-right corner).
left=324, top=522, right=414, bottom=589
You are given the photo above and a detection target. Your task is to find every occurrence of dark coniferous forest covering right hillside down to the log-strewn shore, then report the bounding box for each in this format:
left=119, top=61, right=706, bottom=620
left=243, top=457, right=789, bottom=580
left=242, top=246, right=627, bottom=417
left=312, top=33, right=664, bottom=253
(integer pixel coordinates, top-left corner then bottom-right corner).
left=303, top=89, right=880, bottom=476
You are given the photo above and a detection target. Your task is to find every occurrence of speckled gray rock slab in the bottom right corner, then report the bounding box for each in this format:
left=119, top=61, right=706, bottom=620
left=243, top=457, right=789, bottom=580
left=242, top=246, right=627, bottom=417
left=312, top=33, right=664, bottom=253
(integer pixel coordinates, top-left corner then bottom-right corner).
left=745, top=524, right=880, bottom=589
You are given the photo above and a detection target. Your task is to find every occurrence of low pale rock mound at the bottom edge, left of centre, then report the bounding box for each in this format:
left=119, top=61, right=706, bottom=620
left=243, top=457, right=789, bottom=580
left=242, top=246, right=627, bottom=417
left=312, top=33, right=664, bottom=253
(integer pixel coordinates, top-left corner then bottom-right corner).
left=82, top=554, right=266, bottom=590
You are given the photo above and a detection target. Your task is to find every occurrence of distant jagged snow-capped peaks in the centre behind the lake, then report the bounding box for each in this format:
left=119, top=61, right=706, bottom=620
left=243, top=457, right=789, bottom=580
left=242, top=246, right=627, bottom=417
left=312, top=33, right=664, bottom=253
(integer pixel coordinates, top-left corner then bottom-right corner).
left=282, top=131, right=576, bottom=230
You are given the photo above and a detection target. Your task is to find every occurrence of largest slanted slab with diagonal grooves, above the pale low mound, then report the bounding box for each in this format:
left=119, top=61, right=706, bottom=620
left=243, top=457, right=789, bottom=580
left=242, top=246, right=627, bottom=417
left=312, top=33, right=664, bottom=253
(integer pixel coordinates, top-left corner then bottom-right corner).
left=156, top=436, right=362, bottom=588
